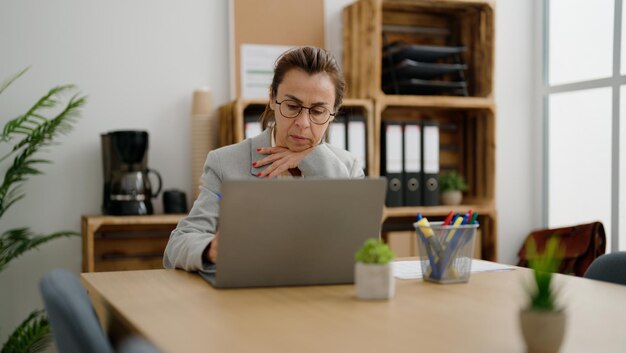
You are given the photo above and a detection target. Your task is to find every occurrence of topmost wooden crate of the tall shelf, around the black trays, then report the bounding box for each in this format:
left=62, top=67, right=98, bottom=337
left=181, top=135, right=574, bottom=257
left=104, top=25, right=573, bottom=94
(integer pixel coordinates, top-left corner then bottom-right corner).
left=343, top=0, right=494, bottom=99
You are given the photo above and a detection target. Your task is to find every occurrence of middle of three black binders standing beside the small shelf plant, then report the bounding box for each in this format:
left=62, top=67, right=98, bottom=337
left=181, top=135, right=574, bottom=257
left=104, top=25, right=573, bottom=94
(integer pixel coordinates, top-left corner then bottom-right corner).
left=403, top=122, right=422, bottom=206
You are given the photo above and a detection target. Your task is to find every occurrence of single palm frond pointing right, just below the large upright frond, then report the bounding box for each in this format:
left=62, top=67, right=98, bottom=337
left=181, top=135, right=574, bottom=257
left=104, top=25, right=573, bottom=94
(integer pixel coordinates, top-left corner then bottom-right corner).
left=0, top=228, right=79, bottom=271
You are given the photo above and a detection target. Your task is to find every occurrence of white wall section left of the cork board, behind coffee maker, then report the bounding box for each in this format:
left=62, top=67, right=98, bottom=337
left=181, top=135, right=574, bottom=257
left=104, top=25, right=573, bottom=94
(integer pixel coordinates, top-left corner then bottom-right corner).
left=0, top=0, right=229, bottom=342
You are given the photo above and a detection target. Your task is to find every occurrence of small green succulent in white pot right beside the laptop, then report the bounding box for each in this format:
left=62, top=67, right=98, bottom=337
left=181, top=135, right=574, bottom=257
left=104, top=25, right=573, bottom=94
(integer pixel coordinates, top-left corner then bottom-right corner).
left=354, top=239, right=396, bottom=299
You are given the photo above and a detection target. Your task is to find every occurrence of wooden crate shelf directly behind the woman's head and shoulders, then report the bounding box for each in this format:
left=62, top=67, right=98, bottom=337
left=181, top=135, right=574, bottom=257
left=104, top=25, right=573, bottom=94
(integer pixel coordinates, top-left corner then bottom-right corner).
left=219, top=99, right=377, bottom=175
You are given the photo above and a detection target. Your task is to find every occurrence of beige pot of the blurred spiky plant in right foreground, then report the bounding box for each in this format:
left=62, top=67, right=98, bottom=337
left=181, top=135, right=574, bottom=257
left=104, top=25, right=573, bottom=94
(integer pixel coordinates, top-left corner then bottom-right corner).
left=520, top=309, right=566, bottom=353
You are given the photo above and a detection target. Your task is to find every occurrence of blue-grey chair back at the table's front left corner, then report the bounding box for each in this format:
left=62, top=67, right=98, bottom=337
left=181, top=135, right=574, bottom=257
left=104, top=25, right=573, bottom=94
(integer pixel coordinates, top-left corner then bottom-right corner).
left=39, top=269, right=114, bottom=353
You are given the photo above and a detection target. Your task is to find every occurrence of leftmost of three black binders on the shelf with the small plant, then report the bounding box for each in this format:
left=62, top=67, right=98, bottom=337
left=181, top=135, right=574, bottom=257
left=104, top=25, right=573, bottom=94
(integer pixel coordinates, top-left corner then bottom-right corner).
left=381, top=121, right=403, bottom=207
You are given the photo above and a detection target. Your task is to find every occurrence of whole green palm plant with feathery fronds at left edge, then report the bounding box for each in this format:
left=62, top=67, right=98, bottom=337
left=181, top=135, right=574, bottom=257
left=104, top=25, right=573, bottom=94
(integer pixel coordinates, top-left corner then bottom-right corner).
left=0, top=68, right=86, bottom=353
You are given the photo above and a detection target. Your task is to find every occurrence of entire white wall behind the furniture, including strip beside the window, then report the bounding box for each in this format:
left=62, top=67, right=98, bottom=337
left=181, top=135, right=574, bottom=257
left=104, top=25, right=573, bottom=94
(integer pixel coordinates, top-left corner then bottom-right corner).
left=0, top=0, right=541, bottom=342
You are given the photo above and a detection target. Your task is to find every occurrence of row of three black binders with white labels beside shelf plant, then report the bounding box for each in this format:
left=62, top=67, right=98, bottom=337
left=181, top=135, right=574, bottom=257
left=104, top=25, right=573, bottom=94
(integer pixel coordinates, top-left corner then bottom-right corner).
left=381, top=121, right=439, bottom=207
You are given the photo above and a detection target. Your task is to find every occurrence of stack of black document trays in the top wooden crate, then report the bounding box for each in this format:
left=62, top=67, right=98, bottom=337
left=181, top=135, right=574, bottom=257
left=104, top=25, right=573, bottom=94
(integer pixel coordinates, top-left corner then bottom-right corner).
left=382, top=42, right=468, bottom=96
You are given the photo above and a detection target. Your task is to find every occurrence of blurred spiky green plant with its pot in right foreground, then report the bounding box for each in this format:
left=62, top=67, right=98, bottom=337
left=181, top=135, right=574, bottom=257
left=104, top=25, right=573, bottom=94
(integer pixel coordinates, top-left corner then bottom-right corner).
left=520, top=237, right=566, bottom=353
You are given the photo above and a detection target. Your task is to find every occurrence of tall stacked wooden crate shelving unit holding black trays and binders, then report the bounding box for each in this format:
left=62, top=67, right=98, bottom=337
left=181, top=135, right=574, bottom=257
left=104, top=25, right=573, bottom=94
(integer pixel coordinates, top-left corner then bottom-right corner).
left=343, top=0, right=497, bottom=260
